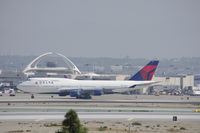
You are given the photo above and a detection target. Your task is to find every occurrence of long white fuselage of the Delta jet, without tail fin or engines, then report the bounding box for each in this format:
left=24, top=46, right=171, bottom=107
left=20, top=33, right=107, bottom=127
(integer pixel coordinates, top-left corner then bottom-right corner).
left=17, top=78, right=155, bottom=93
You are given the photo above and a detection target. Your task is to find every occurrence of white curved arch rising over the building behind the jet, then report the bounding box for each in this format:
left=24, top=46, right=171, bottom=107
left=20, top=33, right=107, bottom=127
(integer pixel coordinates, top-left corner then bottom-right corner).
left=23, top=52, right=81, bottom=74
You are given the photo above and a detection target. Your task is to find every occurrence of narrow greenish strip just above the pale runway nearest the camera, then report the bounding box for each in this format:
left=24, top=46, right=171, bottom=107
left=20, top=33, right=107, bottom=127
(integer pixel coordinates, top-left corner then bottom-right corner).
left=0, top=105, right=196, bottom=113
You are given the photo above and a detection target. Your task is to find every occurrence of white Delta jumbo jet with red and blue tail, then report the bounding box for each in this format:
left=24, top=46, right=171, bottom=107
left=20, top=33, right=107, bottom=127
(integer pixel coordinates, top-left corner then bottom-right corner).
left=18, top=60, right=159, bottom=98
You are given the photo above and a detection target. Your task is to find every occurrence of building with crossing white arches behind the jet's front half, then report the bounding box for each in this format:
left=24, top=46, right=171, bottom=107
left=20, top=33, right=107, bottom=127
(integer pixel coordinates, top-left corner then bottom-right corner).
left=23, top=52, right=81, bottom=77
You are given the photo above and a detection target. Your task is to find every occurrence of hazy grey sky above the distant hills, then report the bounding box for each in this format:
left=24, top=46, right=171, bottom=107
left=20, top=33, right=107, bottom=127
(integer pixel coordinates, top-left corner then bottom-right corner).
left=0, top=0, right=200, bottom=58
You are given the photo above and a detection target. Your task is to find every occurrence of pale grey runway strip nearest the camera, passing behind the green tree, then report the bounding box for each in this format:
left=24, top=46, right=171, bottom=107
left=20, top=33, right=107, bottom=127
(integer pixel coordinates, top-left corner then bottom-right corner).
left=0, top=112, right=200, bottom=121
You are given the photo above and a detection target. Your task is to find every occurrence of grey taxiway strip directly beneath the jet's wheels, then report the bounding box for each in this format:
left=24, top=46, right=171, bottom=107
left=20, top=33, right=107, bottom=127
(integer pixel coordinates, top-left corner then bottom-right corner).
left=0, top=93, right=200, bottom=105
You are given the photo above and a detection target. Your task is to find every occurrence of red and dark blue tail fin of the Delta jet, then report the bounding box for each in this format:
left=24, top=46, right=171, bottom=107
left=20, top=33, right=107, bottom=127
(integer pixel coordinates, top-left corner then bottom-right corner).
left=129, top=60, right=159, bottom=81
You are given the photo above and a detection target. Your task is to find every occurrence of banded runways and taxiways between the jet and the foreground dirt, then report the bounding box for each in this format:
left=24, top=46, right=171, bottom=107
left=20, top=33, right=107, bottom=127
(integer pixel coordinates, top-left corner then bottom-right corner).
left=0, top=94, right=200, bottom=120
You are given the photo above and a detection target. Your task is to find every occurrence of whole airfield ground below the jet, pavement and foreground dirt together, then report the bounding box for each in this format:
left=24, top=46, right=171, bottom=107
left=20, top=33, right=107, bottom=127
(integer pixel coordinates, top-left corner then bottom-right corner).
left=0, top=94, right=200, bottom=133
